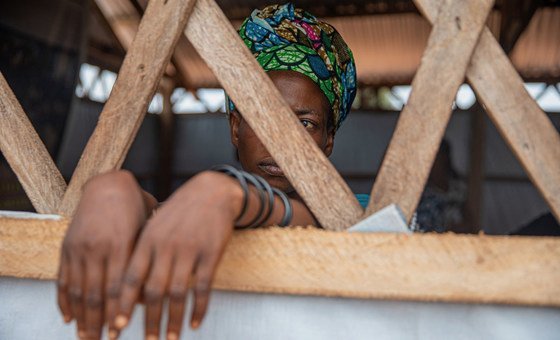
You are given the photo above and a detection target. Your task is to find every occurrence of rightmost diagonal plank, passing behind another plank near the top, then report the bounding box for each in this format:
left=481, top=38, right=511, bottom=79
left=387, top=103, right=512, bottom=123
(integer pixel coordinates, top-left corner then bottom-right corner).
left=416, top=0, right=560, bottom=221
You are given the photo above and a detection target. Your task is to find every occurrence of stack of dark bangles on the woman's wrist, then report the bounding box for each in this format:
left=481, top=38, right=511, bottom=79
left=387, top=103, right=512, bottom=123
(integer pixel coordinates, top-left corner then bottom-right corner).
left=210, top=164, right=293, bottom=229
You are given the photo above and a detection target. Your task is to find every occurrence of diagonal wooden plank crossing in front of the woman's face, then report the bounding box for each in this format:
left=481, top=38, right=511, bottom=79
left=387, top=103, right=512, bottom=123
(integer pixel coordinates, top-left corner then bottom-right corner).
left=185, top=0, right=363, bottom=230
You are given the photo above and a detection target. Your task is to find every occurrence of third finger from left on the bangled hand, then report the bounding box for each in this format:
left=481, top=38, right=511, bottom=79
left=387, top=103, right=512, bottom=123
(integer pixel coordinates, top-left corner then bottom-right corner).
left=167, top=249, right=196, bottom=340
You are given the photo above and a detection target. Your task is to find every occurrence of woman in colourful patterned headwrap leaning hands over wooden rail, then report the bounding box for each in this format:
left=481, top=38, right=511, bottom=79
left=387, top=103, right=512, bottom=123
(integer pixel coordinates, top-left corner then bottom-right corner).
left=58, top=4, right=356, bottom=339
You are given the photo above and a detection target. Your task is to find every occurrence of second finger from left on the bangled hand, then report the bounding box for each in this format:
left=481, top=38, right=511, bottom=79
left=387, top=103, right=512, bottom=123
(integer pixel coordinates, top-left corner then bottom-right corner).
left=143, top=248, right=173, bottom=340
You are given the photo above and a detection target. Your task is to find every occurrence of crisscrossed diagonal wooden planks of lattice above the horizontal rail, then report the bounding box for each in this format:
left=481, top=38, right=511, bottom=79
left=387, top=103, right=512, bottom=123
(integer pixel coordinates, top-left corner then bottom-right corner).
left=0, top=0, right=560, bottom=230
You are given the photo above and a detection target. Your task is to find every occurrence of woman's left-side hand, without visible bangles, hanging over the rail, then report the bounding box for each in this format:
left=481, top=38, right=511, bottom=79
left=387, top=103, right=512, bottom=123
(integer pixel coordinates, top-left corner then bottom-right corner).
left=58, top=171, right=157, bottom=339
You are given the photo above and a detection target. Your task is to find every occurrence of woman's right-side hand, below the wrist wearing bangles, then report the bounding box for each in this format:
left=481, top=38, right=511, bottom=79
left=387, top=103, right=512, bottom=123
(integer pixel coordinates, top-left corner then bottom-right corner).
left=115, top=172, right=243, bottom=339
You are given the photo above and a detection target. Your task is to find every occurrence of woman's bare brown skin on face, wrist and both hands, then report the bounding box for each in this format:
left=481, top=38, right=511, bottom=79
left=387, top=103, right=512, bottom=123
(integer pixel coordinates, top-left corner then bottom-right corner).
left=58, top=71, right=334, bottom=340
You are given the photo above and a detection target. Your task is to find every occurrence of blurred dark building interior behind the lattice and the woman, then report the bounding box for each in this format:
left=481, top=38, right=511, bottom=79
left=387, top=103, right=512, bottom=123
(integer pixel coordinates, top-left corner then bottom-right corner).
left=0, top=0, right=560, bottom=233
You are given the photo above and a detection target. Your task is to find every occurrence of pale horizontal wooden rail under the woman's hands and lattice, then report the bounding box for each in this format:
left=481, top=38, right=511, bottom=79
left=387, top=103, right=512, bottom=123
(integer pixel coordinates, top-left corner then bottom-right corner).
left=0, top=218, right=560, bottom=307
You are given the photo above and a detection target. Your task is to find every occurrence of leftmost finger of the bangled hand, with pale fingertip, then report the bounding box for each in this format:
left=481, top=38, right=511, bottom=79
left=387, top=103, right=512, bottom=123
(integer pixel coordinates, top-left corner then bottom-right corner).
left=114, top=238, right=152, bottom=330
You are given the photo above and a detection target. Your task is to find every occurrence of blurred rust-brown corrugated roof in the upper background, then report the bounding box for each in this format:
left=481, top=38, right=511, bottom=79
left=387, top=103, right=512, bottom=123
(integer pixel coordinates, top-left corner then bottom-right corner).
left=86, top=4, right=560, bottom=88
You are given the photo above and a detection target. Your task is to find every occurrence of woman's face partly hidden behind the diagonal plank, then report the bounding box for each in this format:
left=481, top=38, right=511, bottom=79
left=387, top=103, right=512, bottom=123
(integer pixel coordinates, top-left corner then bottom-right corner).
left=230, top=71, right=334, bottom=193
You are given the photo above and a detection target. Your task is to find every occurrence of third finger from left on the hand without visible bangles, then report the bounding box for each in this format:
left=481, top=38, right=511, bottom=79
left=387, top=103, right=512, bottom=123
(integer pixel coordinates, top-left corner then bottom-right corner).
left=84, top=255, right=105, bottom=339
